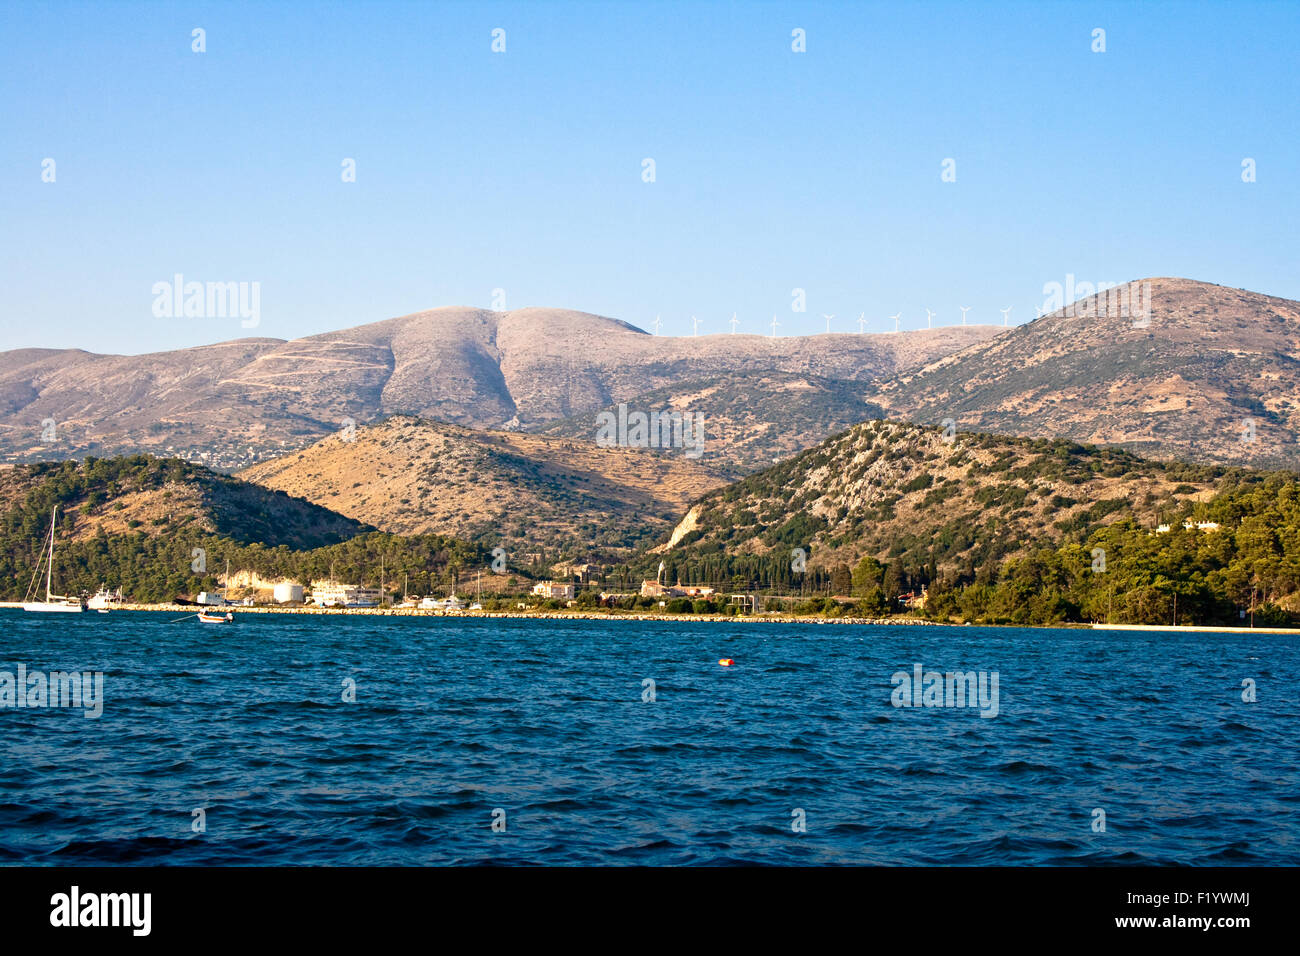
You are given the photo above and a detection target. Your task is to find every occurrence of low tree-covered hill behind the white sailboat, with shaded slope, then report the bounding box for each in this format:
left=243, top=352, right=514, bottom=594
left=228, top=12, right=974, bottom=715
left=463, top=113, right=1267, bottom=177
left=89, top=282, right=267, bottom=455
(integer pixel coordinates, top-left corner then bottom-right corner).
left=0, top=455, right=490, bottom=601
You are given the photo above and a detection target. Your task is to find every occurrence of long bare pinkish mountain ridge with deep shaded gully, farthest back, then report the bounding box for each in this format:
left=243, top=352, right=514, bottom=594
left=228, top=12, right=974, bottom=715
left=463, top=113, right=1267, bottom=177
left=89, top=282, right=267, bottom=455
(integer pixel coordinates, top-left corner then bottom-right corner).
left=0, top=308, right=1001, bottom=468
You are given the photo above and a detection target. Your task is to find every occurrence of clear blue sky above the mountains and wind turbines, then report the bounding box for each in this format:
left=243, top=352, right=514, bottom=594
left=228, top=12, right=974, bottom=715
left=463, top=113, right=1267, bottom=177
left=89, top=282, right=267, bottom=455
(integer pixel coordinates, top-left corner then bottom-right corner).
left=0, top=0, right=1300, bottom=352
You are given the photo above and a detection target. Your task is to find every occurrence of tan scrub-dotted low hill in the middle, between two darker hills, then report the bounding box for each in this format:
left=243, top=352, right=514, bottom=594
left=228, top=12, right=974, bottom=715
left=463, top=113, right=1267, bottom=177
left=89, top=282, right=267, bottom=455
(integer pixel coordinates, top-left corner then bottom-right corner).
left=239, top=416, right=724, bottom=559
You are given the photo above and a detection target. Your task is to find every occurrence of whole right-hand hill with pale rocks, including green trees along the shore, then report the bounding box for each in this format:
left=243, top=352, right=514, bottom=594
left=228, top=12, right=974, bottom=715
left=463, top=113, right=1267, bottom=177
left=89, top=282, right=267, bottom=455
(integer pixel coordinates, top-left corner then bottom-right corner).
left=646, top=421, right=1300, bottom=623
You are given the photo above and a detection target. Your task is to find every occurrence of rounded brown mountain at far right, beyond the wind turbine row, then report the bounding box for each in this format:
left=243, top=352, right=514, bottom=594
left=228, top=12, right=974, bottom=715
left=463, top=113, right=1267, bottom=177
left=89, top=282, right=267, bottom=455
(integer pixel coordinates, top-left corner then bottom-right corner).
left=868, top=278, right=1300, bottom=468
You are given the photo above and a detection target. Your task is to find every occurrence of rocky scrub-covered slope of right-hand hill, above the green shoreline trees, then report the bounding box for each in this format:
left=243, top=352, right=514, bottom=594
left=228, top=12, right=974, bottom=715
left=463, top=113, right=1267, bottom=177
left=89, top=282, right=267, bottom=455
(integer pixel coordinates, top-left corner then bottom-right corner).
left=655, top=421, right=1245, bottom=579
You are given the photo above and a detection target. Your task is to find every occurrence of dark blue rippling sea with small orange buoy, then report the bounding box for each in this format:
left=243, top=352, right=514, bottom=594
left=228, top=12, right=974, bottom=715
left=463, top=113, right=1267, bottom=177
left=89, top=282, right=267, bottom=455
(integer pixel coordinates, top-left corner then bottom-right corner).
left=0, top=610, right=1300, bottom=865
